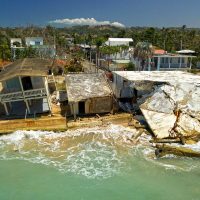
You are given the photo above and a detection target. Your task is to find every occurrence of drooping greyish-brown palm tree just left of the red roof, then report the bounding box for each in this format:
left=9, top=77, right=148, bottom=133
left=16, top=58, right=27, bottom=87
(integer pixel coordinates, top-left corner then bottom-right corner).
left=133, top=42, right=154, bottom=71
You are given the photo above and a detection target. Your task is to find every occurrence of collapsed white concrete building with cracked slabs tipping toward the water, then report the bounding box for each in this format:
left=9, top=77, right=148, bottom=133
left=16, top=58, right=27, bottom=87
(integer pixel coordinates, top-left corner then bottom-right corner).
left=112, top=71, right=200, bottom=138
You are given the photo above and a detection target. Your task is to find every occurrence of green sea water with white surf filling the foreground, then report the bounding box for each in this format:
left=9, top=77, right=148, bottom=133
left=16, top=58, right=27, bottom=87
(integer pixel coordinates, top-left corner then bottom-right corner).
left=0, top=125, right=200, bottom=200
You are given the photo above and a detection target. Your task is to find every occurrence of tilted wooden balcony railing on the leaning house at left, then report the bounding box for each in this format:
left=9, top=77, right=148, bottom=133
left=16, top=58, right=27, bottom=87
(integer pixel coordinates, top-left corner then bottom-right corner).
left=0, top=88, right=47, bottom=102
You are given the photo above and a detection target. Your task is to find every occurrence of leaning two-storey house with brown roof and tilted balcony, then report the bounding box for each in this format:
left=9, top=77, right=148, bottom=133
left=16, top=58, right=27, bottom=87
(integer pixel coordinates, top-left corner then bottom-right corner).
left=0, top=58, right=52, bottom=116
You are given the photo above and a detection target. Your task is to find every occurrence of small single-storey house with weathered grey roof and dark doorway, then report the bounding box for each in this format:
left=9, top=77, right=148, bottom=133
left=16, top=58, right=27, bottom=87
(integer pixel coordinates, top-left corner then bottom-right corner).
left=66, top=74, right=113, bottom=119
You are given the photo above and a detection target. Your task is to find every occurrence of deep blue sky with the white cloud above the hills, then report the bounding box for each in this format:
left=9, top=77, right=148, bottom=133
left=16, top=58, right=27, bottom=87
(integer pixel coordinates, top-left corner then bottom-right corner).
left=0, top=0, right=200, bottom=28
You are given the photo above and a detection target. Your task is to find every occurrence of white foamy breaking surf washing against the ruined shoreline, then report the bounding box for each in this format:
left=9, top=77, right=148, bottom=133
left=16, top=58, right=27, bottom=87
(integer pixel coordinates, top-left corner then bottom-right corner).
left=0, top=125, right=200, bottom=179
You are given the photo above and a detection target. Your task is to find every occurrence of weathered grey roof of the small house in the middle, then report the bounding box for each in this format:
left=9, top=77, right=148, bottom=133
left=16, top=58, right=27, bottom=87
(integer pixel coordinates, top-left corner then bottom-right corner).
left=66, top=73, right=112, bottom=102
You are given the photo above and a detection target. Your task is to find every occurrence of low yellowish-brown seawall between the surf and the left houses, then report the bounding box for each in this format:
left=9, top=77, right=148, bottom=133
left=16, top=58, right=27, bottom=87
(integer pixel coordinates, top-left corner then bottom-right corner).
left=0, top=113, right=132, bottom=135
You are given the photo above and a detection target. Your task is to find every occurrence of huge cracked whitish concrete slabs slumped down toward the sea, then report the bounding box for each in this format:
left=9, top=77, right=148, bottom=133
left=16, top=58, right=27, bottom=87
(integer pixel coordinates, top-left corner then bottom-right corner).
left=139, top=82, right=200, bottom=138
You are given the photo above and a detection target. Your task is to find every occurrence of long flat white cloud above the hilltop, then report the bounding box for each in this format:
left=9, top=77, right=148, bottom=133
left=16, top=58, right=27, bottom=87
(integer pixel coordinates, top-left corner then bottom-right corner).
left=49, top=18, right=125, bottom=27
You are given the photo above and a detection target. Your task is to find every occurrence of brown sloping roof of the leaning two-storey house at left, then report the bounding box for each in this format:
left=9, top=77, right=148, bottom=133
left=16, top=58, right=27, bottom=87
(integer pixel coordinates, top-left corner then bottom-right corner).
left=0, top=58, right=53, bottom=81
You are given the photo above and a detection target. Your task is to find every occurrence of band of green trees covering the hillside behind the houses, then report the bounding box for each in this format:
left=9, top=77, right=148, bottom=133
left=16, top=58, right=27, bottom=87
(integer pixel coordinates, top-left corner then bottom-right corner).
left=0, top=25, right=200, bottom=65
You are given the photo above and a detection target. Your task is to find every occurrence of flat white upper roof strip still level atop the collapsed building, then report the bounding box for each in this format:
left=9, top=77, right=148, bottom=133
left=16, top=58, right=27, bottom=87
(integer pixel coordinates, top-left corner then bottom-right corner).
left=113, top=71, right=200, bottom=84
